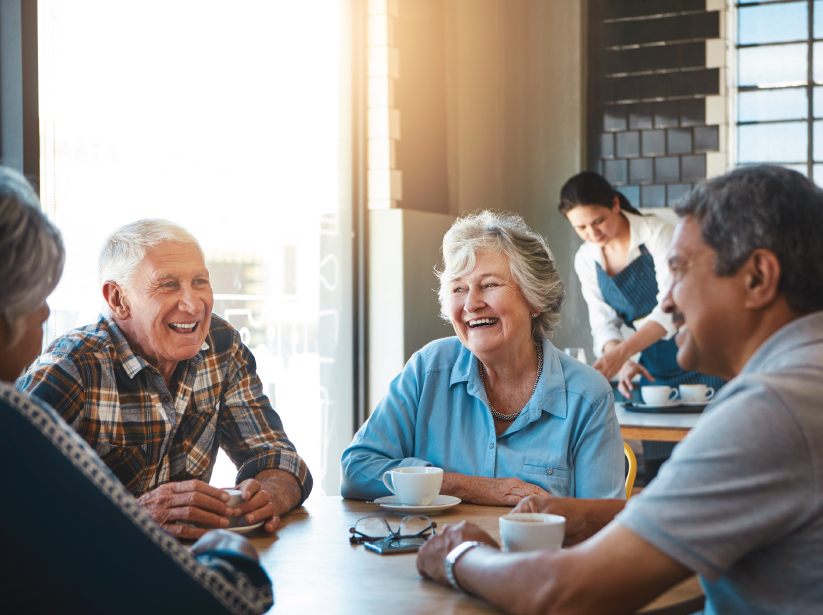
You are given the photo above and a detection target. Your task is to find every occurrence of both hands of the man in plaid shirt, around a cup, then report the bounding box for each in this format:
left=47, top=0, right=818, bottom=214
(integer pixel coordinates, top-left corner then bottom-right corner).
left=137, top=478, right=276, bottom=539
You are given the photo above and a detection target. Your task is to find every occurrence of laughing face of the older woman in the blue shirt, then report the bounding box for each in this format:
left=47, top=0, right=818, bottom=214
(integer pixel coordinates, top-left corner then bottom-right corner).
left=448, top=252, right=535, bottom=363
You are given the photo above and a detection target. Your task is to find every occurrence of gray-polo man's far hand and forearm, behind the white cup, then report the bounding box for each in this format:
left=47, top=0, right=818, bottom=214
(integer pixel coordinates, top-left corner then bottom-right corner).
left=512, top=497, right=626, bottom=547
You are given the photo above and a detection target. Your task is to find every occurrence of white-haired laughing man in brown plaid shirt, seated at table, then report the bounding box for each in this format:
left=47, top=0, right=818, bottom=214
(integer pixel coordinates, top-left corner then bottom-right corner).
left=17, top=220, right=312, bottom=538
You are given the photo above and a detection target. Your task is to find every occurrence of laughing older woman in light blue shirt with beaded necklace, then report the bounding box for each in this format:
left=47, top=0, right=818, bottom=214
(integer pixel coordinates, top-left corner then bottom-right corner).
left=341, top=211, right=625, bottom=506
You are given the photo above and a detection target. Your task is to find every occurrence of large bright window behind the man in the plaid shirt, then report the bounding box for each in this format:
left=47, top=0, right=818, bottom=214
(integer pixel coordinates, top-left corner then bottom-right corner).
left=39, top=0, right=354, bottom=494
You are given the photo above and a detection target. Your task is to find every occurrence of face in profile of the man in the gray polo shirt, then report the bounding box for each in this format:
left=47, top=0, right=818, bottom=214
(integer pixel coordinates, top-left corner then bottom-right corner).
left=662, top=217, right=748, bottom=379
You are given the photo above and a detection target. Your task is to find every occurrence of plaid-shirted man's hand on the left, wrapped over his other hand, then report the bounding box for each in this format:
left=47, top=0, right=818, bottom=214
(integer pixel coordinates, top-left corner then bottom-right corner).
left=137, top=480, right=232, bottom=538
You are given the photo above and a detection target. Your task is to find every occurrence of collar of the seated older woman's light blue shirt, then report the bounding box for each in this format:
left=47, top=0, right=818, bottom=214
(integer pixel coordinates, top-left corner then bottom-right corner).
left=449, top=339, right=566, bottom=422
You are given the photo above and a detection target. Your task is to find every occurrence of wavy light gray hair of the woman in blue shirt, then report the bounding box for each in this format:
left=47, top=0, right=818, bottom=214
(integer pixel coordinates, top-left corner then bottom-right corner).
left=436, top=210, right=565, bottom=341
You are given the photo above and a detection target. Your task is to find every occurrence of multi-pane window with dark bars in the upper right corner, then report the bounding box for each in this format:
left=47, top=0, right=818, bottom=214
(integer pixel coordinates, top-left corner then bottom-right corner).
left=736, top=0, right=823, bottom=183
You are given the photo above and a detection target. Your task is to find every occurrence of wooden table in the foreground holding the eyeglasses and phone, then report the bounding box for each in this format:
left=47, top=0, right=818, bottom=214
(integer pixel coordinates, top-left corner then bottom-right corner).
left=249, top=496, right=700, bottom=615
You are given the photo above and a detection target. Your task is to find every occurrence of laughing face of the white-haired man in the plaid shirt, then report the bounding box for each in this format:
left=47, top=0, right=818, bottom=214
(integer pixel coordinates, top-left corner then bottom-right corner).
left=108, top=242, right=214, bottom=378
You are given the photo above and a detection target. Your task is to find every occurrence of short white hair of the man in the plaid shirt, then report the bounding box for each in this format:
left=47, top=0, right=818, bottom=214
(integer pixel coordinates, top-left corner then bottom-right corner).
left=97, top=219, right=205, bottom=288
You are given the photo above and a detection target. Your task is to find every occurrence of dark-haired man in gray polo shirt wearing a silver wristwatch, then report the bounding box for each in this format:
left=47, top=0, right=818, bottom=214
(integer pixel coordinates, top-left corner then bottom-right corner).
left=418, top=166, right=823, bottom=615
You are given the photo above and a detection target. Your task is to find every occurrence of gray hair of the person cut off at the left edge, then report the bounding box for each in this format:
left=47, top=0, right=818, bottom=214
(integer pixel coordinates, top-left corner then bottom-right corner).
left=0, top=166, right=66, bottom=332
